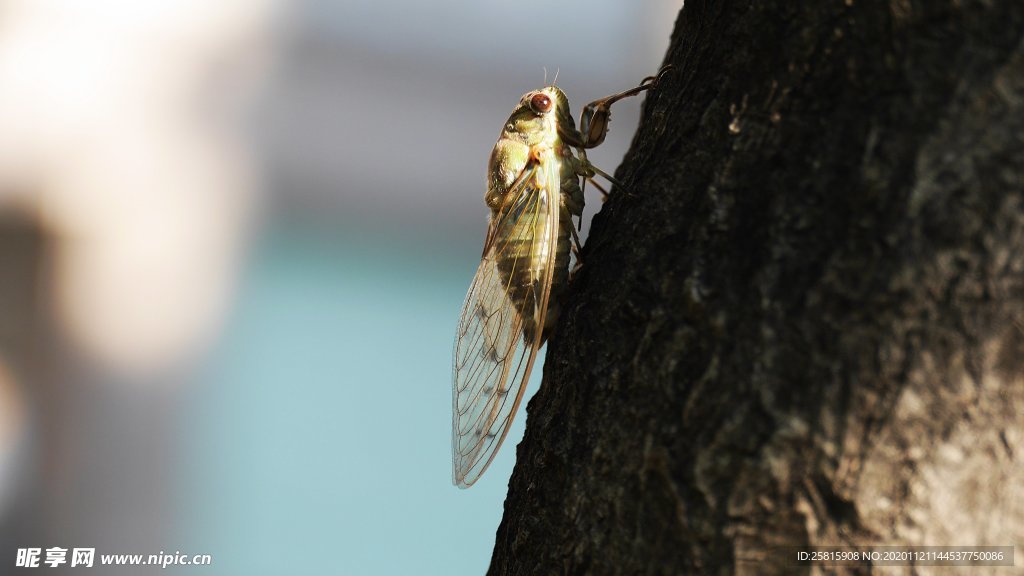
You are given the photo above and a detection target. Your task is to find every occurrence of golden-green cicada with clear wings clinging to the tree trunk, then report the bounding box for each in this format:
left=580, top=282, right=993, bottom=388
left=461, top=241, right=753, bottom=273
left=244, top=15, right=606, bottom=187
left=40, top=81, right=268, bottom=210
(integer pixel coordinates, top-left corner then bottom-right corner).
left=452, top=67, right=668, bottom=488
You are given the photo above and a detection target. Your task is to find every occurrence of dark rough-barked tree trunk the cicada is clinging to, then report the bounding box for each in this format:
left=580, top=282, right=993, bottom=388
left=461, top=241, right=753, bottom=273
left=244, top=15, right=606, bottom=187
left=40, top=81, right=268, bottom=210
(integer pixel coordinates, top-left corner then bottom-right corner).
left=490, top=0, right=1024, bottom=574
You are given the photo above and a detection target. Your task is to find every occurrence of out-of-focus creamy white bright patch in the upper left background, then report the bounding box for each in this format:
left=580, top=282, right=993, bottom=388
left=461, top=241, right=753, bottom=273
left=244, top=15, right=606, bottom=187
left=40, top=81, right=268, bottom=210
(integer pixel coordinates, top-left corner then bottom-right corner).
left=0, top=0, right=276, bottom=371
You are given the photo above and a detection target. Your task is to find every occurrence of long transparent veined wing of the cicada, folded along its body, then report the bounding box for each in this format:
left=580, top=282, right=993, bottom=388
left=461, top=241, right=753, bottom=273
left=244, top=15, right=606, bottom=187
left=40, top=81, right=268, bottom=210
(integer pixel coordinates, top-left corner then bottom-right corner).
left=452, top=151, right=559, bottom=488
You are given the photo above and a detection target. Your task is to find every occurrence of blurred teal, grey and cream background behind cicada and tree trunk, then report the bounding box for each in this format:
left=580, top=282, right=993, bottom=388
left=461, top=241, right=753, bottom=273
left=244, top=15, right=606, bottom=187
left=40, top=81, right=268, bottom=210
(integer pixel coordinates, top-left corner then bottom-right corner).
left=0, top=0, right=682, bottom=575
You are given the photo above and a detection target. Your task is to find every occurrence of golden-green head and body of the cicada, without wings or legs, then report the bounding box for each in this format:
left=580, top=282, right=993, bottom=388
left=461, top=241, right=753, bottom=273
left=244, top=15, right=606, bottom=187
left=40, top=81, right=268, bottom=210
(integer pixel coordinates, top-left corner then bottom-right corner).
left=484, top=86, right=584, bottom=341
